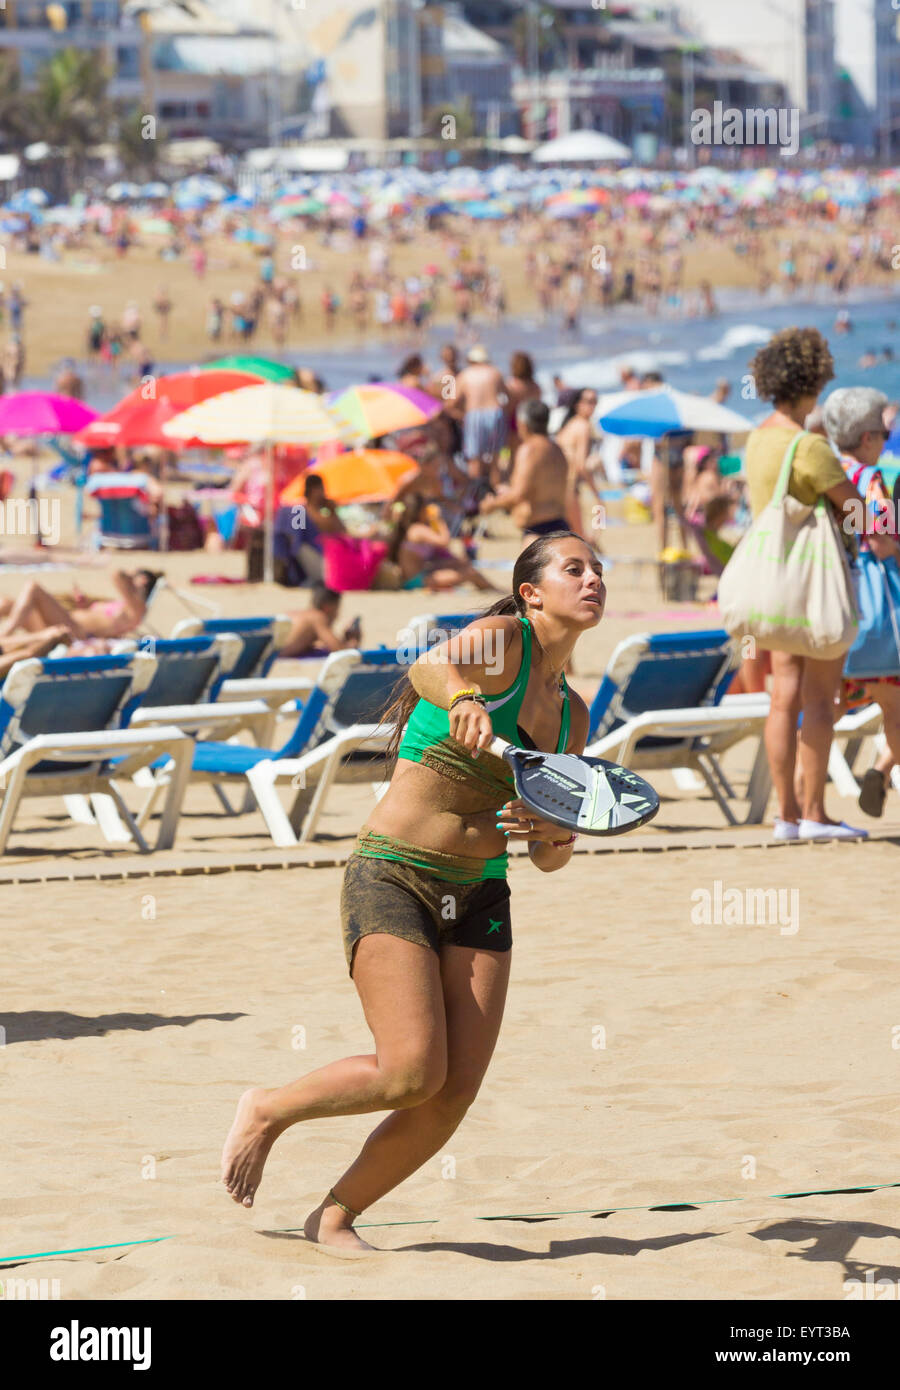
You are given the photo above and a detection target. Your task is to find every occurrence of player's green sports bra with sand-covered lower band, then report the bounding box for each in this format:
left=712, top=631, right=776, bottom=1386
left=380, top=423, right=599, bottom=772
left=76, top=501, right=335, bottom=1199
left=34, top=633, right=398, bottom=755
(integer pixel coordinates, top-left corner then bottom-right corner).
left=398, top=617, right=569, bottom=795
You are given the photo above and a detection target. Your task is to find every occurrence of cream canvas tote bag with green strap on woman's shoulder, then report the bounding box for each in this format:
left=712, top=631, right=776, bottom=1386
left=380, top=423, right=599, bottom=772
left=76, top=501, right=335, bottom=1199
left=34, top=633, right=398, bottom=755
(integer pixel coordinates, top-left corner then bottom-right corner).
left=719, top=430, right=858, bottom=662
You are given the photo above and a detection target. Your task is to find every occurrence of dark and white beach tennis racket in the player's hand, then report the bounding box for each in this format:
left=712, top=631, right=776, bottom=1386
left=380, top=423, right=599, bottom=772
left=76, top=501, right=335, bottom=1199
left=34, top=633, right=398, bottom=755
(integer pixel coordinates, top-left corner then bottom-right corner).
left=490, top=738, right=659, bottom=835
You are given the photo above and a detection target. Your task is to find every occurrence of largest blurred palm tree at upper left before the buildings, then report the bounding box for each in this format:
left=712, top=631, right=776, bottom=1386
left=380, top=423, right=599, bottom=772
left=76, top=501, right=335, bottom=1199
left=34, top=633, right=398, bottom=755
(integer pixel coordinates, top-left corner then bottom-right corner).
left=35, top=49, right=113, bottom=194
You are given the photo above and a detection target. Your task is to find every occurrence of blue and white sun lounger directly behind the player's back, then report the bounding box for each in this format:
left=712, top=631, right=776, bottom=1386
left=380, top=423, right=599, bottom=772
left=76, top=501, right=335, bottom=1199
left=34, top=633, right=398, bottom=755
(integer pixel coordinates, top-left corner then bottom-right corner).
left=138, top=648, right=406, bottom=845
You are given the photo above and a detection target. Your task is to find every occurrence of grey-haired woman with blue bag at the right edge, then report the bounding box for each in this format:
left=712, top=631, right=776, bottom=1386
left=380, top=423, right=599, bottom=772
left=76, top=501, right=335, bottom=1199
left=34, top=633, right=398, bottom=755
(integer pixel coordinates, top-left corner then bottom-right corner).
left=823, top=386, right=900, bottom=816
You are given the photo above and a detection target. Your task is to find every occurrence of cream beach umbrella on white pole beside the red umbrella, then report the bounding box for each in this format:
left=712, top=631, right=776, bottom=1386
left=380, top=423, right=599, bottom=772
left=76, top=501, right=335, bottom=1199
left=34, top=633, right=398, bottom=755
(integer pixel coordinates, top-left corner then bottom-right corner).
left=163, top=381, right=364, bottom=584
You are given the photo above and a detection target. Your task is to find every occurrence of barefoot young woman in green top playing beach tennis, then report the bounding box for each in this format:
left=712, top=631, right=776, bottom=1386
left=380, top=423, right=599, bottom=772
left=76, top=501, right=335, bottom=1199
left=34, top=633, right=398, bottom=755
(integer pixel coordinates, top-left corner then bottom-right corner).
left=223, top=531, right=606, bottom=1254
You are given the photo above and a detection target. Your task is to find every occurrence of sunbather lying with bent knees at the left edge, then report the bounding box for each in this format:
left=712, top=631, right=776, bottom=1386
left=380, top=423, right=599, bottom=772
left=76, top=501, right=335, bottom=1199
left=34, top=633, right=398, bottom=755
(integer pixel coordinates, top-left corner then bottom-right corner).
left=0, top=570, right=163, bottom=641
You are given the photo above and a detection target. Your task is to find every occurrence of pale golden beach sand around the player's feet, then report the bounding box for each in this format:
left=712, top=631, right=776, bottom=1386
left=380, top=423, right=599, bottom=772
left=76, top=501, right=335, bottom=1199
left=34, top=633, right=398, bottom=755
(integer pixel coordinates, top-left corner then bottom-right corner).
left=0, top=527, right=900, bottom=1301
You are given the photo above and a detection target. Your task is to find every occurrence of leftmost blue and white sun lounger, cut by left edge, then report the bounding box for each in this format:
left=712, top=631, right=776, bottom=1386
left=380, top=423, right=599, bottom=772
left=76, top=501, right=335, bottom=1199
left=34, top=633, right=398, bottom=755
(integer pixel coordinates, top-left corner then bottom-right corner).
left=0, top=652, right=193, bottom=853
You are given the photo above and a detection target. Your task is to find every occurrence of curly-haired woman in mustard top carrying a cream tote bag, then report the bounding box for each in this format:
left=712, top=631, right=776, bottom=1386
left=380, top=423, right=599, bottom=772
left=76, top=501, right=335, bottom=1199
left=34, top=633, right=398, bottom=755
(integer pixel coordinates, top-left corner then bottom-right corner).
left=734, top=328, right=889, bottom=840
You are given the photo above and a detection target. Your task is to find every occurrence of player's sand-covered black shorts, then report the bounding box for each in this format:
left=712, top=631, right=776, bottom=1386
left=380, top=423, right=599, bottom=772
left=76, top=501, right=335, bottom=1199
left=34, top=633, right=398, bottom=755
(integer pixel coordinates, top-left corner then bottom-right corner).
left=341, top=855, right=512, bottom=976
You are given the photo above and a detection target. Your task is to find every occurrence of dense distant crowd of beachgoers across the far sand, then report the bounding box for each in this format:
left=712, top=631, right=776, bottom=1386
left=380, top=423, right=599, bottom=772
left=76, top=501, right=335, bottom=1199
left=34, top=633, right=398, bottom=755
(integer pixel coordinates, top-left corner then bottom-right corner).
left=0, top=166, right=897, bottom=391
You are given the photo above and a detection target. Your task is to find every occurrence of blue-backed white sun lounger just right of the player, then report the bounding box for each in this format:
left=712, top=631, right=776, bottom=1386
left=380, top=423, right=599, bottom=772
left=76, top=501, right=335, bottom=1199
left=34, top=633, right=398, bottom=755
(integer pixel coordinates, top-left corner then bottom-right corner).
left=586, top=630, right=769, bottom=826
